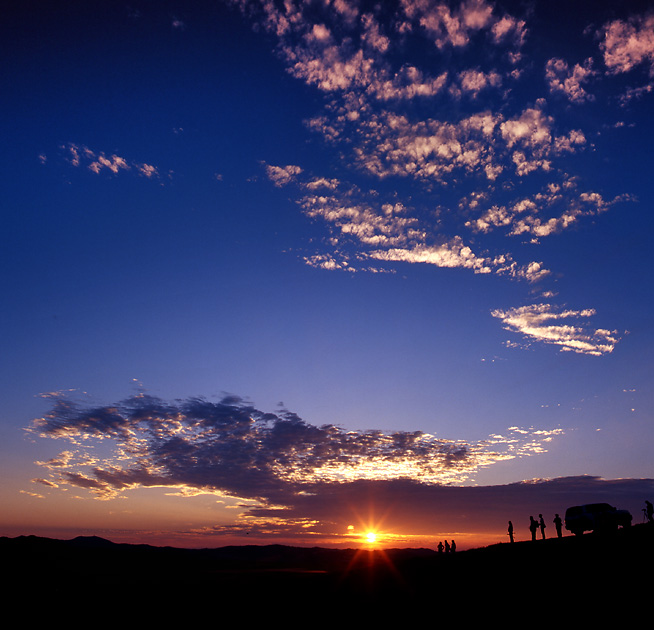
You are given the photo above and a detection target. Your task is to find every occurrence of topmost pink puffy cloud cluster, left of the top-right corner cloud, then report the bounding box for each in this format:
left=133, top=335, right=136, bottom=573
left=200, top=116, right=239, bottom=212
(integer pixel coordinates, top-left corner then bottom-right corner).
left=232, top=0, right=525, bottom=108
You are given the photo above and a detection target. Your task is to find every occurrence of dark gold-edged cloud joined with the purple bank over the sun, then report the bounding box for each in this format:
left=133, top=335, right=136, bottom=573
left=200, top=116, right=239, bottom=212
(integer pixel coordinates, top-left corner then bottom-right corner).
left=25, top=394, right=654, bottom=541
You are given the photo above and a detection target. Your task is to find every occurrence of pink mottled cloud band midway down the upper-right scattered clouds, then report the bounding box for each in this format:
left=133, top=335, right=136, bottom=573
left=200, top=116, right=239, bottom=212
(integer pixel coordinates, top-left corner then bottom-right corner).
left=309, top=108, right=586, bottom=183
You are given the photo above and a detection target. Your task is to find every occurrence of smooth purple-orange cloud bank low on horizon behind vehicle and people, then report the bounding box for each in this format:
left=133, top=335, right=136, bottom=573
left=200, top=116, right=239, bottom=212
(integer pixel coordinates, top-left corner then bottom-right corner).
left=237, top=475, right=654, bottom=542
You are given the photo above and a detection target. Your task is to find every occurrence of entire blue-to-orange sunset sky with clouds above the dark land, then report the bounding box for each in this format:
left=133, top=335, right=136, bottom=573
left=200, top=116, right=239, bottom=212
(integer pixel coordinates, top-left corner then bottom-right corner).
left=0, top=0, right=654, bottom=548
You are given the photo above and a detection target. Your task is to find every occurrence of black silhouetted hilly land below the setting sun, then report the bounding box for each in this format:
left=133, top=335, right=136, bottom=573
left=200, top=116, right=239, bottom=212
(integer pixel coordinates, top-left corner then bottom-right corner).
left=0, top=525, right=654, bottom=627
